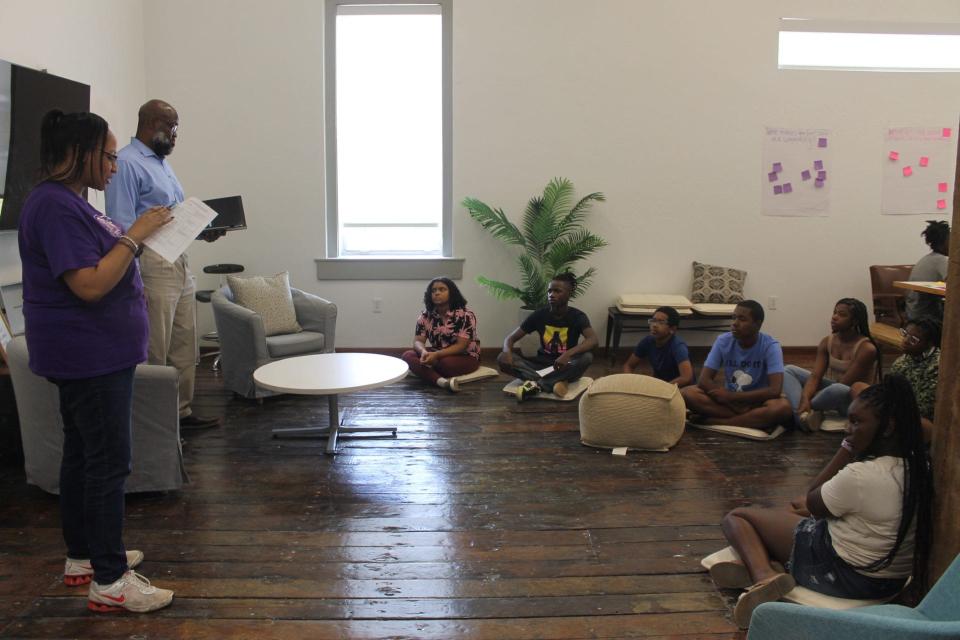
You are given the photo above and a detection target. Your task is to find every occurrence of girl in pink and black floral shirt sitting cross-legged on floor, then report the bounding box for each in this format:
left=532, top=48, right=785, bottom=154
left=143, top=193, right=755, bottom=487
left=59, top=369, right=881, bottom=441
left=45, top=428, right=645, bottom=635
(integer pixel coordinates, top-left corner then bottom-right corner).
left=402, top=278, right=480, bottom=392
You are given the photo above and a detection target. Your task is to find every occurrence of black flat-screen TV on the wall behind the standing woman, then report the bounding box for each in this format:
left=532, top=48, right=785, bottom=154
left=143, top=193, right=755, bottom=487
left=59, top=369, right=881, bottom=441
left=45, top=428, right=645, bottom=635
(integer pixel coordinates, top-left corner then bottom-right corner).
left=0, top=60, right=90, bottom=231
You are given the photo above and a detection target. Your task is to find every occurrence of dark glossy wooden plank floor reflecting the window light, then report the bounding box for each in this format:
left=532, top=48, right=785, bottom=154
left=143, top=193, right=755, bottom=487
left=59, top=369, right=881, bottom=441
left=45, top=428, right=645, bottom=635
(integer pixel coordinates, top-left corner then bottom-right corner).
left=0, top=352, right=840, bottom=640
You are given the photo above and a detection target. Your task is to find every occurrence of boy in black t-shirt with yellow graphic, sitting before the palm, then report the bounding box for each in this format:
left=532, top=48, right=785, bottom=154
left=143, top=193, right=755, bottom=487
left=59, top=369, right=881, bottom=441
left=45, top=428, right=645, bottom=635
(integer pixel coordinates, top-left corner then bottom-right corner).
left=497, top=273, right=597, bottom=401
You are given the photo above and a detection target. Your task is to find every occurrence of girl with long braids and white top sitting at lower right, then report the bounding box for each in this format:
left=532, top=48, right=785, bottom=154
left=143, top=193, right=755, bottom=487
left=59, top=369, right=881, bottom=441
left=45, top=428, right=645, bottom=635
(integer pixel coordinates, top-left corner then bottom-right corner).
left=710, top=374, right=933, bottom=628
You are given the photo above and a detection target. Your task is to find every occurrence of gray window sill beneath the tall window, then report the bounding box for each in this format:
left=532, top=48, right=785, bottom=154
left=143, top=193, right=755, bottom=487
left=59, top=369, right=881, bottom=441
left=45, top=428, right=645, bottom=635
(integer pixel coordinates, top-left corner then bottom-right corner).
left=314, top=258, right=464, bottom=280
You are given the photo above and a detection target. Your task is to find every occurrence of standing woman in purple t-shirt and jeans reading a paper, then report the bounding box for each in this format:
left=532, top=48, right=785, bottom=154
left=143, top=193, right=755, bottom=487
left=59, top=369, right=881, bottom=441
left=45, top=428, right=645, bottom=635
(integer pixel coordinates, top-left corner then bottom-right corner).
left=18, top=110, right=173, bottom=611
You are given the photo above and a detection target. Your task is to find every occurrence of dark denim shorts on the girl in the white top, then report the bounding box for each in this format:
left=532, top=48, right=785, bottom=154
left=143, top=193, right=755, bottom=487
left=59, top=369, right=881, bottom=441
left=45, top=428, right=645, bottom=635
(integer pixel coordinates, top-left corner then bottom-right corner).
left=787, top=518, right=907, bottom=600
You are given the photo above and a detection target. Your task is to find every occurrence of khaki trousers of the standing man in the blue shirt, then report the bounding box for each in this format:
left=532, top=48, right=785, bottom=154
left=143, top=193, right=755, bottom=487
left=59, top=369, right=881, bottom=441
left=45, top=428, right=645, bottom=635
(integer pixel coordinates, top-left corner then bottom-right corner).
left=140, top=247, right=197, bottom=418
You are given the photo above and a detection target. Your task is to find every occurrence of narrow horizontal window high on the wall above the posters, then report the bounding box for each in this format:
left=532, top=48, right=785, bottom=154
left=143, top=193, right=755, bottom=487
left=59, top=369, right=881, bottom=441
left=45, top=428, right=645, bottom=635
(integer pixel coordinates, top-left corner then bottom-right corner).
left=778, top=19, right=960, bottom=72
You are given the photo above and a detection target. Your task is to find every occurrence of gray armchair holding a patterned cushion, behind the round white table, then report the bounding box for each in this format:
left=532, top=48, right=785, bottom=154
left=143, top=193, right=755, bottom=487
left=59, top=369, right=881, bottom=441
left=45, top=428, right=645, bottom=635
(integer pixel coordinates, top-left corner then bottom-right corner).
left=210, top=287, right=337, bottom=398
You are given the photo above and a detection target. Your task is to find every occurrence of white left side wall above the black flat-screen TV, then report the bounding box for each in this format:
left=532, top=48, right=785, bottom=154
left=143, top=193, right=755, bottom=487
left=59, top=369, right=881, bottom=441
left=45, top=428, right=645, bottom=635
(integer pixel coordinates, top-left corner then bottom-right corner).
left=0, top=0, right=146, bottom=282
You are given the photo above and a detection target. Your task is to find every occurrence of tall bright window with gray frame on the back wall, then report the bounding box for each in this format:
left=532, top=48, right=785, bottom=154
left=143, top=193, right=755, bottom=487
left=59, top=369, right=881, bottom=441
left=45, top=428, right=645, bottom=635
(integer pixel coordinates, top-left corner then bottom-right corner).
left=325, top=0, right=452, bottom=257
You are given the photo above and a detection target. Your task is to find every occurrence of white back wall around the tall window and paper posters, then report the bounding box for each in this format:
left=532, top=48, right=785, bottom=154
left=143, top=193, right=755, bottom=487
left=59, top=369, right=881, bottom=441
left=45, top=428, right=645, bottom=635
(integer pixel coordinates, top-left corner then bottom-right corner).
left=0, top=0, right=960, bottom=347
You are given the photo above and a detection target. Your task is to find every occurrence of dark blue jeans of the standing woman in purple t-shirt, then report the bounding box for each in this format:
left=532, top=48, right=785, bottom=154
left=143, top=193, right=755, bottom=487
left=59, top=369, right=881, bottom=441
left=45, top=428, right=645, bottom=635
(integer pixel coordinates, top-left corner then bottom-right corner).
left=51, top=367, right=136, bottom=584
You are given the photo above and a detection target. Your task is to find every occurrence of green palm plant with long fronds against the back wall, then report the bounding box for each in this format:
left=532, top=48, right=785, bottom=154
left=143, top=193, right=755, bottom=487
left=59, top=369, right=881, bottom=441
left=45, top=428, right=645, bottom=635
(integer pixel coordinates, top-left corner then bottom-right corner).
left=461, top=178, right=607, bottom=309
